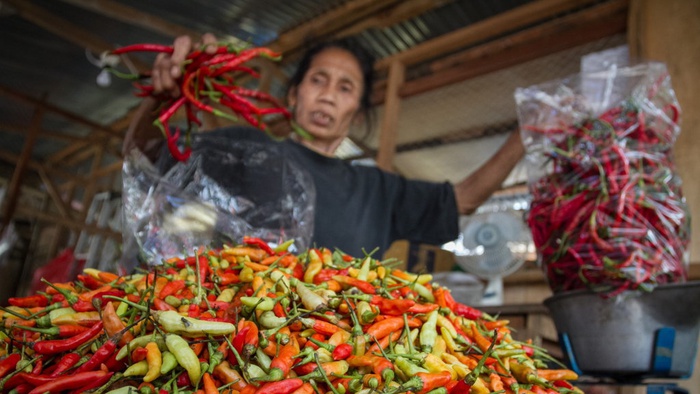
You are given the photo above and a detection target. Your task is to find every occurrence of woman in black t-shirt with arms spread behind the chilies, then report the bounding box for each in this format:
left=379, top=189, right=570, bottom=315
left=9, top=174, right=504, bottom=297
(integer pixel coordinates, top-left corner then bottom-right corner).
left=125, top=34, right=524, bottom=256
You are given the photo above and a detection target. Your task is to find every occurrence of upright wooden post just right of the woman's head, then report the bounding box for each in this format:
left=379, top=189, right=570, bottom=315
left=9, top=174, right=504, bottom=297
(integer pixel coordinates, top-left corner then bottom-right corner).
left=377, top=60, right=406, bottom=171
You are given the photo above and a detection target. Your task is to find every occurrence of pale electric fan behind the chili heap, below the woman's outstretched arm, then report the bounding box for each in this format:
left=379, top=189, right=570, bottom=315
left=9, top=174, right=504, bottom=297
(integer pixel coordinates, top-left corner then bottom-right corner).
left=442, top=211, right=534, bottom=305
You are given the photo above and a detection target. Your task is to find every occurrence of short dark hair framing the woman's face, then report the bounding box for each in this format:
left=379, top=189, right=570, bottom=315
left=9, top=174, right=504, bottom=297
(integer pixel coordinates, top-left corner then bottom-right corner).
left=287, top=38, right=375, bottom=138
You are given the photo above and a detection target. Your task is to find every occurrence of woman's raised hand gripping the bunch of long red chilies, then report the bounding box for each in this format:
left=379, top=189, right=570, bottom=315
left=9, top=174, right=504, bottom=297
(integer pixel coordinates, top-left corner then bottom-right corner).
left=151, top=33, right=217, bottom=97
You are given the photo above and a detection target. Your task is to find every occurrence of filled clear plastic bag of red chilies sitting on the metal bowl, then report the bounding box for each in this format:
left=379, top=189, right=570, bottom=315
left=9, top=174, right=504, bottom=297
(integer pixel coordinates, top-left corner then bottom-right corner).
left=515, top=62, right=690, bottom=297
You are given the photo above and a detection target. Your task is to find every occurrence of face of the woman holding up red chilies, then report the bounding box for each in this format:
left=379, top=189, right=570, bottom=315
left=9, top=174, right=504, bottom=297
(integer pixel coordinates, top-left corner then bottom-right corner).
left=288, top=48, right=364, bottom=154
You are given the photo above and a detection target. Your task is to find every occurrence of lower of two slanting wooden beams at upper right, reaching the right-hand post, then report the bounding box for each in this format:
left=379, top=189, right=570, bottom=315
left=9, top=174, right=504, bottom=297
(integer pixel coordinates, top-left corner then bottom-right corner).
left=400, top=5, right=627, bottom=97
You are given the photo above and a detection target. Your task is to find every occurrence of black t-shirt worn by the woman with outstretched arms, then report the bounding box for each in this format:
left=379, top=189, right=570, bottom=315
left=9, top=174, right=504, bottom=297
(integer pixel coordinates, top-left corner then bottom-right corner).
left=161, top=127, right=458, bottom=256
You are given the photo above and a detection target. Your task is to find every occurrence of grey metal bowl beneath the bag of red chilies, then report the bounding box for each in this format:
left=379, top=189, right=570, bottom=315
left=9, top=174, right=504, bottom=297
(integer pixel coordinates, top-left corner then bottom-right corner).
left=544, top=281, right=700, bottom=380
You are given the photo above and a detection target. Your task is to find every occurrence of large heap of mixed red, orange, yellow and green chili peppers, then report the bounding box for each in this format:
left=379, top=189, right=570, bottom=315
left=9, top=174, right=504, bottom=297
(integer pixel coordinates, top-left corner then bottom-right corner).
left=0, top=238, right=581, bottom=394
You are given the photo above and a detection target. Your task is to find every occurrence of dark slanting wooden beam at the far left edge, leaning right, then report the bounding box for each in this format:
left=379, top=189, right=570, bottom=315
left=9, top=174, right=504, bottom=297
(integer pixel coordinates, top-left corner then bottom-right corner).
left=0, top=106, right=44, bottom=232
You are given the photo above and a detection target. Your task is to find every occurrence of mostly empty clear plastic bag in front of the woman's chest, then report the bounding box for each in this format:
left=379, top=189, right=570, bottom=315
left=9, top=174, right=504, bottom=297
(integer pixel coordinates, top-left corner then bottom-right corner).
left=121, top=132, right=316, bottom=271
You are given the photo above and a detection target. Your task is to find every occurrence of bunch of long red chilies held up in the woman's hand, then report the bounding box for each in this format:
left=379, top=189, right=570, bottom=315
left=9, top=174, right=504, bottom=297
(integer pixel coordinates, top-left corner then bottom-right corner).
left=111, top=44, right=291, bottom=161
